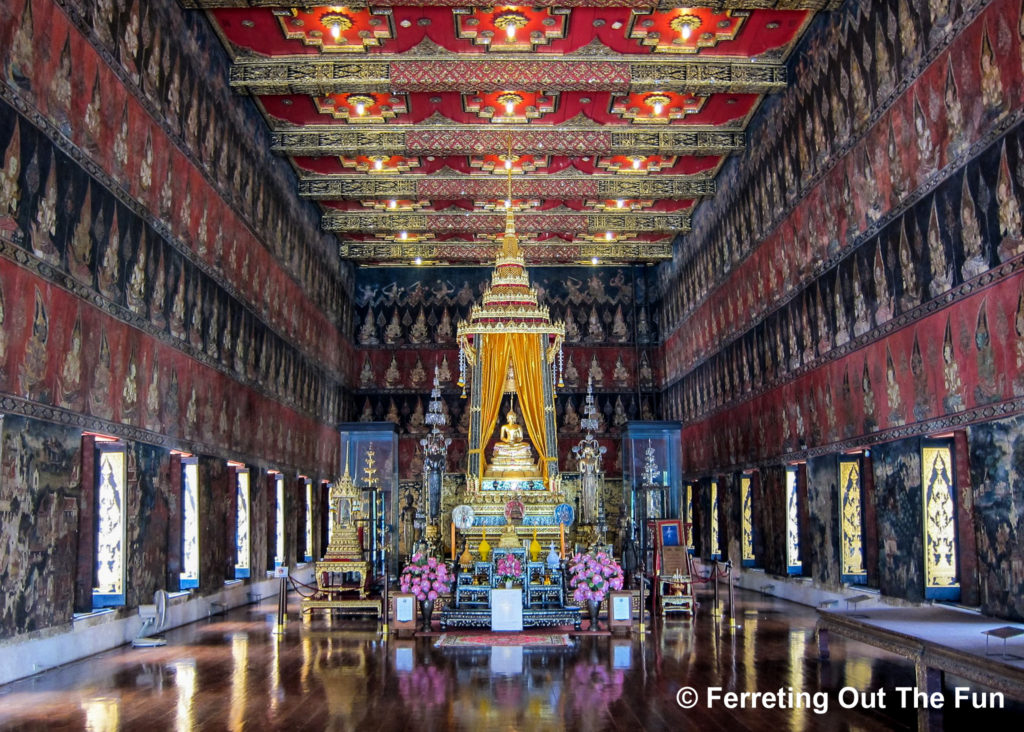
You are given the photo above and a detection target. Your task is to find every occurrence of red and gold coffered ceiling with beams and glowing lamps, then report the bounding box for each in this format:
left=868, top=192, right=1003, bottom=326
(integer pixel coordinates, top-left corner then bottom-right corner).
left=193, top=0, right=835, bottom=264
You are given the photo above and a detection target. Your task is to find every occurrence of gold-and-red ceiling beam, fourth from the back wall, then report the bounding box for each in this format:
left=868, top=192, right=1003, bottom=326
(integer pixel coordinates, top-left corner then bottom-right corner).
left=270, top=123, right=743, bottom=157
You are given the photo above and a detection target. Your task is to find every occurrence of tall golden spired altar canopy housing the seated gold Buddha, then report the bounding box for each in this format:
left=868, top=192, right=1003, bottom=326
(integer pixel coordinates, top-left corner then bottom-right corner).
left=458, top=200, right=565, bottom=548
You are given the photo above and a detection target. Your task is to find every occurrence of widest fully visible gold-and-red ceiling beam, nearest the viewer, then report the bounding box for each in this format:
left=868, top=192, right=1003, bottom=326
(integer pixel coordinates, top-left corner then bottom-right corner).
left=231, top=58, right=786, bottom=95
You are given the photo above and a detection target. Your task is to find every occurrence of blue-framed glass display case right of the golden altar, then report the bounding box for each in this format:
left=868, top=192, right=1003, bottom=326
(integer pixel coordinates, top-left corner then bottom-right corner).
left=622, top=421, right=683, bottom=570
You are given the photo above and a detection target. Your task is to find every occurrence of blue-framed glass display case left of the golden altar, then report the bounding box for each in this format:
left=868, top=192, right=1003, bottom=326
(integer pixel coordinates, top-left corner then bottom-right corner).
left=338, top=422, right=398, bottom=575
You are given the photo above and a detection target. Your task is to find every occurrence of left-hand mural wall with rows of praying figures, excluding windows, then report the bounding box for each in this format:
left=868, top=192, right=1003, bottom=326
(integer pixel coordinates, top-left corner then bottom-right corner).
left=0, top=0, right=344, bottom=638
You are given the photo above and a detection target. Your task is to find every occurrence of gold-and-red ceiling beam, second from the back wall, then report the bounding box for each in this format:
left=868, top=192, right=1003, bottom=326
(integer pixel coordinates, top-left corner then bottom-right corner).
left=321, top=210, right=690, bottom=234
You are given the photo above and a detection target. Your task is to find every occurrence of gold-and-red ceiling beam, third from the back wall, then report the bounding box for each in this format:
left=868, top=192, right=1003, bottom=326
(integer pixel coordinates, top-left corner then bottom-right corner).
left=299, top=173, right=716, bottom=201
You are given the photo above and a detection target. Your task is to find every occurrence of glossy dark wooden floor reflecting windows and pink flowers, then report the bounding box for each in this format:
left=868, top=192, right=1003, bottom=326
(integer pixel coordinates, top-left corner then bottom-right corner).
left=0, top=593, right=1024, bottom=732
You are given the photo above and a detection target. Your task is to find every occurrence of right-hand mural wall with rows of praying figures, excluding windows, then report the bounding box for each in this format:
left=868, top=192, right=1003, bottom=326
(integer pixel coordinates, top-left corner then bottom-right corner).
left=656, top=0, right=1024, bottom=617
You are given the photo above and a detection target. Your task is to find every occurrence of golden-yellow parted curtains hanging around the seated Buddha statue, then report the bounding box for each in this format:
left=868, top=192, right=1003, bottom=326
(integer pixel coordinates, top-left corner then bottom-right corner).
left=478, top=333, right=548, bottom=481
